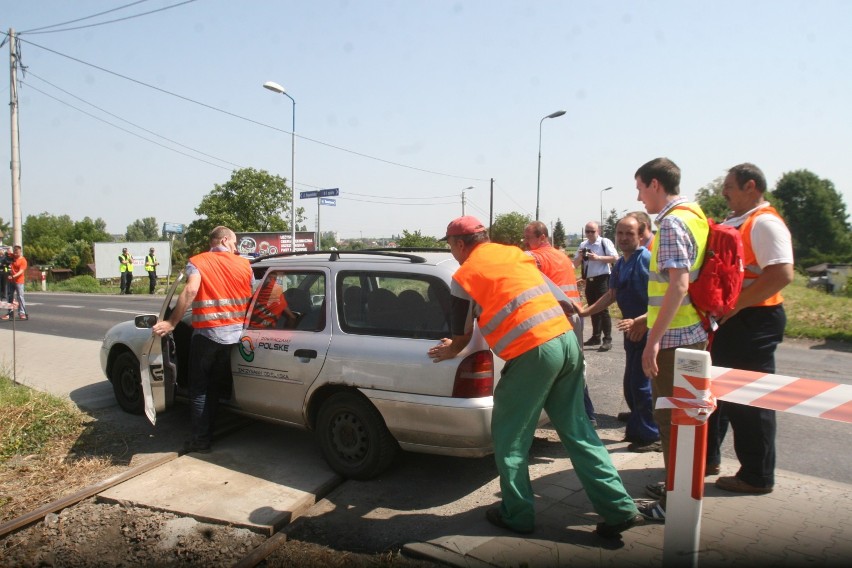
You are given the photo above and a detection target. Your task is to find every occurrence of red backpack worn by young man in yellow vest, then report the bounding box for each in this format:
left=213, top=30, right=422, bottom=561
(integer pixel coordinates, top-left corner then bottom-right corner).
left=680, top=206, right=745, bottom=332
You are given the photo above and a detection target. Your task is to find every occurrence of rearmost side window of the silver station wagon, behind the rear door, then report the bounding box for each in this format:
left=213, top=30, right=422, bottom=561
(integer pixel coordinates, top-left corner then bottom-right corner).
left=337, top=271, right=450, bottom=339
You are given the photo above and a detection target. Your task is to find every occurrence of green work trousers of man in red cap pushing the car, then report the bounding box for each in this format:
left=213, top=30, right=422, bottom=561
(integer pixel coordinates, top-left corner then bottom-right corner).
left=491, top=332, right=637, bottom=531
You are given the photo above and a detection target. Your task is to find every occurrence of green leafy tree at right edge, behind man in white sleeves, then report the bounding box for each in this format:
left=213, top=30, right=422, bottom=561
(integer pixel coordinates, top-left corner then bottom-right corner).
left=772, top=170, right=852, bottom=267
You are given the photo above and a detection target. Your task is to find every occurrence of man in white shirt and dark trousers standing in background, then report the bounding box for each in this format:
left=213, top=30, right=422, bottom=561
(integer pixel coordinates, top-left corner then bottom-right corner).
left=574, top=221, right=618, bottom=351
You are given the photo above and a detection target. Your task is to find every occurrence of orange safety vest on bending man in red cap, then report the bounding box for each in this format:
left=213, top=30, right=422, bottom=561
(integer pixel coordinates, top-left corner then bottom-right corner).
left=453, top=243, right=571, bottom=360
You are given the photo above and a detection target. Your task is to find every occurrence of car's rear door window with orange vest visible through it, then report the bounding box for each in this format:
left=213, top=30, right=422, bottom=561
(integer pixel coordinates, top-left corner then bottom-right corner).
left=248, top=270, right=326, bottom=331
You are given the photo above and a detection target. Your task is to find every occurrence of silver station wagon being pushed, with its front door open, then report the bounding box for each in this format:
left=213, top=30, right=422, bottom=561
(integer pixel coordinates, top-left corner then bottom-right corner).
left=101, top=249, right=503, bottom=479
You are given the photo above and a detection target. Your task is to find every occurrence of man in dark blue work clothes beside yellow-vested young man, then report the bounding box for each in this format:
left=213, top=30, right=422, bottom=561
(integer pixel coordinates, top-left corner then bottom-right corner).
left=580, top=216, right=662, bottom=452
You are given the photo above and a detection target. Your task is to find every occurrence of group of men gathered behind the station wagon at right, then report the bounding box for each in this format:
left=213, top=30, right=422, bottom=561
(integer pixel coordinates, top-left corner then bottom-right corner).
left=428, top=158, right=793, bottom=537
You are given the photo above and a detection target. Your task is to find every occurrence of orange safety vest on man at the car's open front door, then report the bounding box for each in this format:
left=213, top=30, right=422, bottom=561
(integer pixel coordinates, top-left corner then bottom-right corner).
left=189, top=251, right=251, bottom=328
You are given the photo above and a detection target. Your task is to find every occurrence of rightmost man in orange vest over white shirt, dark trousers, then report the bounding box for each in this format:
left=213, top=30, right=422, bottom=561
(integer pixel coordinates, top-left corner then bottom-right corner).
left=707, top=163, right=793, bottom=493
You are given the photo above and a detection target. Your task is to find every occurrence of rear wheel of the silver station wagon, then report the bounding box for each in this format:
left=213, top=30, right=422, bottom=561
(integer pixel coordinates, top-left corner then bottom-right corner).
left=316, top=392, right=399, bottom=479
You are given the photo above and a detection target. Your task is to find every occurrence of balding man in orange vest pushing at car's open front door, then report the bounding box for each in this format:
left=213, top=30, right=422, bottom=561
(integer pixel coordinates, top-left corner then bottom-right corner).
left=152, top=226, right=254, bottom=453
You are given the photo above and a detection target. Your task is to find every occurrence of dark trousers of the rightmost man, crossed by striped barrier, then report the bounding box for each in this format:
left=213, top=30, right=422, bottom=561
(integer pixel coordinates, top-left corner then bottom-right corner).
left=707, top=305, right=787, bottom=487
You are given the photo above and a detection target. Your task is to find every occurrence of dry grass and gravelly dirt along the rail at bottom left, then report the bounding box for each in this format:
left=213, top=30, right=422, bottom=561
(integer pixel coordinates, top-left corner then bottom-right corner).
left=0, top=406, right=436, bottom=568
